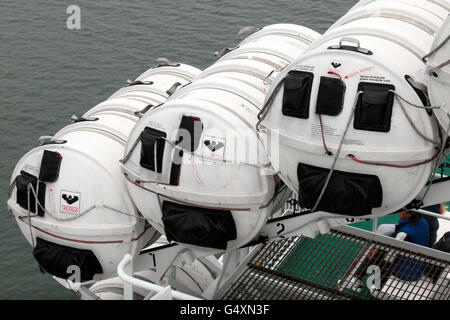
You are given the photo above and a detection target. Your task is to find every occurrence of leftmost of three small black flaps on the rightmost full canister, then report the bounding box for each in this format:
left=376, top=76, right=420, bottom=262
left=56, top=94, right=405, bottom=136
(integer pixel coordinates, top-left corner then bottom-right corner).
left=282, top=70, right=314, bottom=119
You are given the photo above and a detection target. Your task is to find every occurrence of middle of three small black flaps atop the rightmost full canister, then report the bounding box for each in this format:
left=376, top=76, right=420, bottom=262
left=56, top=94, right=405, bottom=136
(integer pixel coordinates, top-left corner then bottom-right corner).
left=316, top=77, right=345, bottom=116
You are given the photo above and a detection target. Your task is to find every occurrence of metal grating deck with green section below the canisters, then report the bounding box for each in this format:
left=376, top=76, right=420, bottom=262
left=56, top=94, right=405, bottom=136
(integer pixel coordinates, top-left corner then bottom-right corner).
left=223, top=230, right=450, bottom=300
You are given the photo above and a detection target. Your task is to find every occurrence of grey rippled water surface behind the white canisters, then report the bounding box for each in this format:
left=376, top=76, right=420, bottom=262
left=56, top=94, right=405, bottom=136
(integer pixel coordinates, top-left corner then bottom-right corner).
left=0, top=0, right=357, bottom=299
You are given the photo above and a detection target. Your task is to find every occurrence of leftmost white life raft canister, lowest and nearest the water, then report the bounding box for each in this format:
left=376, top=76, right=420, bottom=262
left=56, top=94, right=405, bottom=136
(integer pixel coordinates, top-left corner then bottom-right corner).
left=8, top=65, right=200, bottom=282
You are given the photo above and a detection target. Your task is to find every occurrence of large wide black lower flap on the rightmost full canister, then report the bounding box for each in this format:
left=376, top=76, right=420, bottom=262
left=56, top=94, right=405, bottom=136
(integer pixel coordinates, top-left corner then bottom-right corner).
left=297, top=163, right=383, bottom=216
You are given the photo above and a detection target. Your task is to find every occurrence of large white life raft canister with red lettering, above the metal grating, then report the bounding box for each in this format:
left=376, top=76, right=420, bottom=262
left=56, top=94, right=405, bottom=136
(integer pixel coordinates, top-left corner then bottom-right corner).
left=258, top=1, right=448, bottom=223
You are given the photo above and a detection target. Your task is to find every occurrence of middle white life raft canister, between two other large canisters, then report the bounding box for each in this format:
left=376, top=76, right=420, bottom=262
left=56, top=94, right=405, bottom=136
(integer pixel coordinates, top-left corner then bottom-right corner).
left=123, top=24, right=318, bottom=252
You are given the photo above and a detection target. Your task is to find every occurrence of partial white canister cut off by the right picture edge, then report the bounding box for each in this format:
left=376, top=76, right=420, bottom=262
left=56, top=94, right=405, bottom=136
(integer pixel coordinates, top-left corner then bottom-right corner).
left=426, top=17, right=450, bottom=131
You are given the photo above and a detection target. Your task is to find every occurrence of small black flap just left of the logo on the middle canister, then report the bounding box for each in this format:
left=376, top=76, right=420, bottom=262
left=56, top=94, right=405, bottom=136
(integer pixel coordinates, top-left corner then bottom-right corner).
left=177, top=116, right=203, bottom=152
